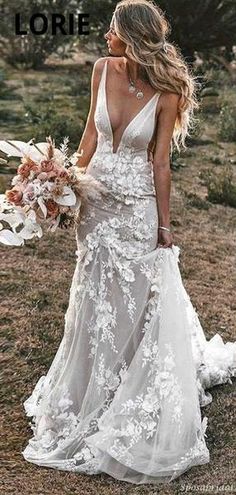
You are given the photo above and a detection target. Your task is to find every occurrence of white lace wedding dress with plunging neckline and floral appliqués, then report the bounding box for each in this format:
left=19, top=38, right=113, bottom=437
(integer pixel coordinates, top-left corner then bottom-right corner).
left=22, top=60, right=236, bottom=484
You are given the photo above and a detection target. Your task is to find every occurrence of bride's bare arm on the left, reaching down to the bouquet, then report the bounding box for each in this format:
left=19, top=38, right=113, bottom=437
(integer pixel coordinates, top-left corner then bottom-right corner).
left=76, top=57, right=106, bottom=167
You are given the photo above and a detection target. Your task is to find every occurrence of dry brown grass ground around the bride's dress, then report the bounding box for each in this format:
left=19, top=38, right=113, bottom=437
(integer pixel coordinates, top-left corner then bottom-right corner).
left=1, top=68, right=236, bottom=495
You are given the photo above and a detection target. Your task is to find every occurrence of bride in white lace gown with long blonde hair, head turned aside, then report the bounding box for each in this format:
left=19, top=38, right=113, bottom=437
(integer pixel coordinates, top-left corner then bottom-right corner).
left=22, top=0, right=236, bottom=484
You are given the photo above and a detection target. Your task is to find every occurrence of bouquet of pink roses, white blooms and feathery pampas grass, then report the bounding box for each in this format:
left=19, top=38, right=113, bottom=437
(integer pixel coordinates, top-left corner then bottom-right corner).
left=0, top=136, right=106, bottom=246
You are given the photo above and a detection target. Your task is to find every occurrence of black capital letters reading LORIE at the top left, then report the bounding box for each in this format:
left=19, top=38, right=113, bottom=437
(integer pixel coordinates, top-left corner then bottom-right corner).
left=15, top=13, right=89, bottom=36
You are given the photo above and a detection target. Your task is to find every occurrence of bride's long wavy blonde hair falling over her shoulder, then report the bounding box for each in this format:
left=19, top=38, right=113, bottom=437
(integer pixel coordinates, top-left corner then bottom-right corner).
left=112, top=0, right=199, bottom=153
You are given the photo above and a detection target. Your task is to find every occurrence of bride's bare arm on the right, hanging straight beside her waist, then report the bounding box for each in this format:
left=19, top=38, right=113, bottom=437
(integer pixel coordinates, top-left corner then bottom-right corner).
left=153, top=93, right=179, bottom=233
